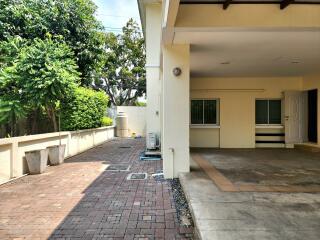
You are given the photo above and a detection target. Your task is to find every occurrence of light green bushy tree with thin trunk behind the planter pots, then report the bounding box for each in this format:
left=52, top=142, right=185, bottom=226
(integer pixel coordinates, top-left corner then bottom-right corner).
left=0, top=35, right=79, bottom=131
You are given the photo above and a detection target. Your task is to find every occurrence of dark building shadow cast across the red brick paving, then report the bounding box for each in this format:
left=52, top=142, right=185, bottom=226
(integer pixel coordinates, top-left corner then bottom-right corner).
left=49, top=139, right=193, bottom=239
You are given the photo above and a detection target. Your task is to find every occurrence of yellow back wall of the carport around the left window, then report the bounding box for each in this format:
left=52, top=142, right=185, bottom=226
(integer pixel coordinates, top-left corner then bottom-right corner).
left=190, top=77, right=303, bottom=148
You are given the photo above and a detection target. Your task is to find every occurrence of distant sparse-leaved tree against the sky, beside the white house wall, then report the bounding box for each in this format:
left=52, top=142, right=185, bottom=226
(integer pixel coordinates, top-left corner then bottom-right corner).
left=95, top=19, right=146, bottom=106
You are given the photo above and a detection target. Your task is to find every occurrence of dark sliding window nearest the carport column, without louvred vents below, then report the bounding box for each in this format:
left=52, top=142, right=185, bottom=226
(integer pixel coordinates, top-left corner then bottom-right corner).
left=191, top=99, right=219, bottom=125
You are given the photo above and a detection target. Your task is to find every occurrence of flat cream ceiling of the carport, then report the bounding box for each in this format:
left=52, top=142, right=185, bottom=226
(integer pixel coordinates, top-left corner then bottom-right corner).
left=174, top=29, right=320, bottom=77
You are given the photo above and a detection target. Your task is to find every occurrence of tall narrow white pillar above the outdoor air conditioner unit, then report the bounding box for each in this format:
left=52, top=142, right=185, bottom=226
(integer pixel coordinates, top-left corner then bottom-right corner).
left=146, top=4, right=161, bottom=146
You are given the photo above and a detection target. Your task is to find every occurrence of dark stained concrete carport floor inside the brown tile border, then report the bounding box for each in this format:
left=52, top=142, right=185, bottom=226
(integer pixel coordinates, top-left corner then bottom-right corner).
left=201, top=149, right=320, bottom=186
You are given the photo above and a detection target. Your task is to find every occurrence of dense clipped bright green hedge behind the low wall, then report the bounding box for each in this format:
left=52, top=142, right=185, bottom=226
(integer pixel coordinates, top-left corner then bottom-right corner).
left=61, top=87, right=108, bottom=131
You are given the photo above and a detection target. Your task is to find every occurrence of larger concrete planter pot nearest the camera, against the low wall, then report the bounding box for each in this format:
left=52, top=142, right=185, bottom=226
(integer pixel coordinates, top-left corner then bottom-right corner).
left=25, top=149, right=48, bottom=174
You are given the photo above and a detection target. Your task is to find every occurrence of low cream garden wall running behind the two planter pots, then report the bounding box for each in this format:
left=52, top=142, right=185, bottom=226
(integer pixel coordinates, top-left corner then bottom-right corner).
left=0, top=126, right=114, bottom=184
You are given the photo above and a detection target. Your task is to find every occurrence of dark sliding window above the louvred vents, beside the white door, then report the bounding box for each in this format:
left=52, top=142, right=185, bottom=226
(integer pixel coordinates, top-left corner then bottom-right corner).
left=256, top=99, right=282, bottom=125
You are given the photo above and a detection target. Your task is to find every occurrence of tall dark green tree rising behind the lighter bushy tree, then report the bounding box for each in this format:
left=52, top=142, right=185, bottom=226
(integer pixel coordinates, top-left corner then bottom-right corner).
left=0, top=0, right=104, bottom=85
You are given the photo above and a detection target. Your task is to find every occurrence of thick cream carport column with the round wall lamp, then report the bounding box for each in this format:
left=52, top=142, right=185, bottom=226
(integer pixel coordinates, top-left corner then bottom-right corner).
left=161, top=45, right=190, bottom=178
